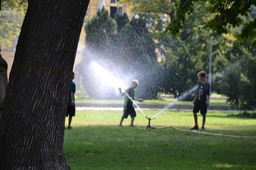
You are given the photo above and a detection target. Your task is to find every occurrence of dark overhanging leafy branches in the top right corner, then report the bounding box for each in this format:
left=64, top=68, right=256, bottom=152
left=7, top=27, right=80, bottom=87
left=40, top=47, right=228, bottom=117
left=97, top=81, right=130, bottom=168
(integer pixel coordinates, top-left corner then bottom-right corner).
left=169, top=0, right=256, bottom=44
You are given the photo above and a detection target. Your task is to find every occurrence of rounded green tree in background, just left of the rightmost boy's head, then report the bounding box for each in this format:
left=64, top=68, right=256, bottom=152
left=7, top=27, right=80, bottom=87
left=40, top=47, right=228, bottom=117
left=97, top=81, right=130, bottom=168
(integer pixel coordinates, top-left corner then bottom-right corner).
left=160, top=35, right=195, bottom=97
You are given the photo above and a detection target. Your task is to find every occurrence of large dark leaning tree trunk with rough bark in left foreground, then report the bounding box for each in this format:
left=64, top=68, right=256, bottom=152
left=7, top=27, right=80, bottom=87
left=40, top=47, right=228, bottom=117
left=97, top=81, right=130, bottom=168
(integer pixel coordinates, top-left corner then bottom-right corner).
left=0, top=0, right=89, bottom=170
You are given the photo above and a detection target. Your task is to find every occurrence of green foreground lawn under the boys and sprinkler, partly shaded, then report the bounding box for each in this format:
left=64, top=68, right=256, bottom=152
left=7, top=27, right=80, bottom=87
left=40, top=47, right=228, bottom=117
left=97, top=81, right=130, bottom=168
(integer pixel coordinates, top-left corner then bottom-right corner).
left=64, top=109, right=256, bottom=170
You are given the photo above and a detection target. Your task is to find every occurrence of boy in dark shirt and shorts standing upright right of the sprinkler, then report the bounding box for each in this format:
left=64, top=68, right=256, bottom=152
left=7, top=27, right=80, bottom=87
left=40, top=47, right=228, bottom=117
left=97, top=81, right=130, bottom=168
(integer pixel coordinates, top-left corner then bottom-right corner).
left=191, top=71, right=210, bottom=130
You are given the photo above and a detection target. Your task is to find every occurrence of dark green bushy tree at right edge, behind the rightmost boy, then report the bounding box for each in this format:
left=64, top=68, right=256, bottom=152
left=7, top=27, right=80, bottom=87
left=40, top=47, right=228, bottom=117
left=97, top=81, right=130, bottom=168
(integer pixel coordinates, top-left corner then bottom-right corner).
left=216, top=47, right=256, bottom=110
